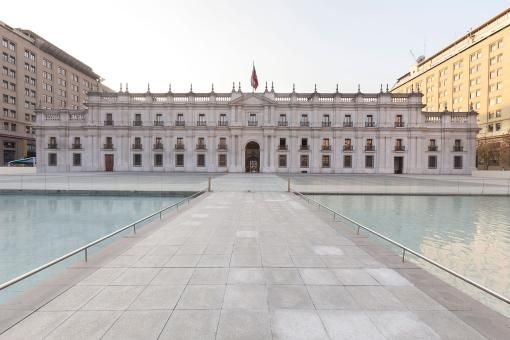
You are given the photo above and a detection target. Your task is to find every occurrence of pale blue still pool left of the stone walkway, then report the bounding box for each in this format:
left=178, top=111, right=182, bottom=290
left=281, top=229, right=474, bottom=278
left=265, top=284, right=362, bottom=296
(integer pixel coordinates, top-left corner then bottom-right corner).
left=0, top=195, right=182, bottom=282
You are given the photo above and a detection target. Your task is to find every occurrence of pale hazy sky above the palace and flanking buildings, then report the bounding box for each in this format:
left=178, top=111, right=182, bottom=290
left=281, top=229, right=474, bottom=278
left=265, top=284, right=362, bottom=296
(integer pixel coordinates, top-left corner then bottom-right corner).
left=0, top=0, right=510, bottom=92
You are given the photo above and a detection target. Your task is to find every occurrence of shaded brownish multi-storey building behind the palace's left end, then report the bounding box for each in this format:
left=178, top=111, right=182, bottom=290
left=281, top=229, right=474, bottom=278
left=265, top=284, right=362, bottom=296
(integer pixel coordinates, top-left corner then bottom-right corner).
left=0, top=21, right=108, bottom=166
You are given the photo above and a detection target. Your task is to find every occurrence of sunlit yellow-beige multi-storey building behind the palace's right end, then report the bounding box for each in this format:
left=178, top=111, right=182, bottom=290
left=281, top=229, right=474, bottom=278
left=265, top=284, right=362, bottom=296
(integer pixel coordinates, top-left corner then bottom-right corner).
left=392, top=9, right=510, bottom=167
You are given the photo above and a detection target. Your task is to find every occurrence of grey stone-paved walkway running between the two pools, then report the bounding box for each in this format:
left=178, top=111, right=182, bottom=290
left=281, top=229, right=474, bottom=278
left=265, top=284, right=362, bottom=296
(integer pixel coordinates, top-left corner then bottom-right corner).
left=0, top=187, right=510, bottom=340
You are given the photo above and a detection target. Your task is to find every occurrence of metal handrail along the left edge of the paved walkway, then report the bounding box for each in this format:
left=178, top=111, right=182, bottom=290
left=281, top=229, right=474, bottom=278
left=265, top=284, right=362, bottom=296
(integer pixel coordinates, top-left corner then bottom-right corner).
left=0, top=190, right=205, bottom=291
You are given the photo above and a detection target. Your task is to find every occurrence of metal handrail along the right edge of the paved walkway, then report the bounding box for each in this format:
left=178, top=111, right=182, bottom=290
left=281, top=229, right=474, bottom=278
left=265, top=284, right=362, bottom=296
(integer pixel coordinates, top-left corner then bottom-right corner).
left=292, top=190, right=510, bottom=304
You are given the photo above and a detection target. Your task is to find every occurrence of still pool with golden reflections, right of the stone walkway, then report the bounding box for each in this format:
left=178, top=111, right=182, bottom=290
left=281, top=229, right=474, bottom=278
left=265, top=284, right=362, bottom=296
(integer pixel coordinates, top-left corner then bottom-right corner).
left=313, top=195, right=510, bottom=297
